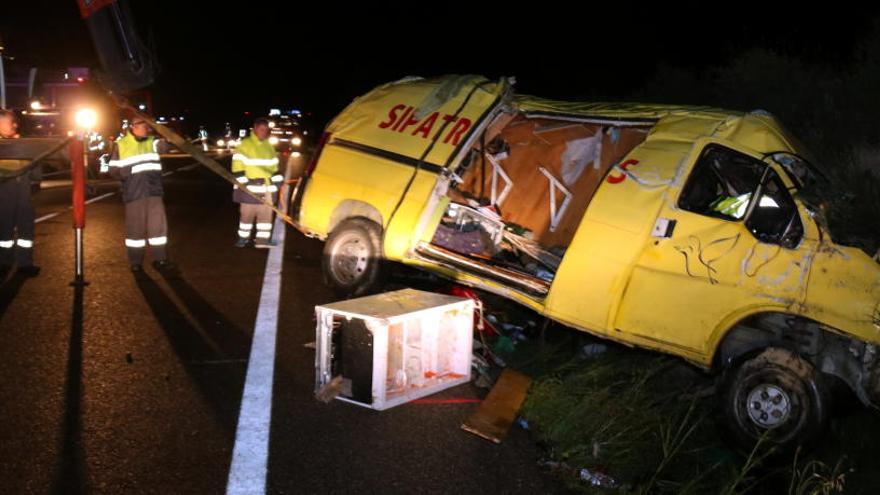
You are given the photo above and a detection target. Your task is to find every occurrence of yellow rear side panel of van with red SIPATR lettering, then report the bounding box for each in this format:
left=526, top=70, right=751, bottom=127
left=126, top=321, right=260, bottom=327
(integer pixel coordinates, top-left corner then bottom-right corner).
left=297, top=76, right=510, bottom=259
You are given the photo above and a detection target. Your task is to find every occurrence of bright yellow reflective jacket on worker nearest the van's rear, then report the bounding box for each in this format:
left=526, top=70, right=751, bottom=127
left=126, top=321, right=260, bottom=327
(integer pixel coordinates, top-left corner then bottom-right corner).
left=232, top=133, right=284, bottom=203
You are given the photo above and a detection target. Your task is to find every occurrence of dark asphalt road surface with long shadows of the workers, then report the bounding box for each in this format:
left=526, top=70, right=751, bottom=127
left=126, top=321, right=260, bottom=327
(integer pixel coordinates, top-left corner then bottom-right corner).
left=0, top=159, right=562, bottom=494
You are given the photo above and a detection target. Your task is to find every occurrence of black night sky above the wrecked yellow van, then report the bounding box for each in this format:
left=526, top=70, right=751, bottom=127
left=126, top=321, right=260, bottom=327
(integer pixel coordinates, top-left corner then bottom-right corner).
left=0, top=0, right=877, bottom=129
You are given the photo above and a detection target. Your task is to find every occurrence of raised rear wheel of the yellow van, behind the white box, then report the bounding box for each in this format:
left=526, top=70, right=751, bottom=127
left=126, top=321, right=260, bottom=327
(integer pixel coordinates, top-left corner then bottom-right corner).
left=321, top=217, right=386, bottom=297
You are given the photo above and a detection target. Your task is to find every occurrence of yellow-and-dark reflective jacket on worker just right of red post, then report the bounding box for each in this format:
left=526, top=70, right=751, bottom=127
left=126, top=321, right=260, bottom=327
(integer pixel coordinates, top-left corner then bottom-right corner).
left=110, top=133, right=164, bottom=203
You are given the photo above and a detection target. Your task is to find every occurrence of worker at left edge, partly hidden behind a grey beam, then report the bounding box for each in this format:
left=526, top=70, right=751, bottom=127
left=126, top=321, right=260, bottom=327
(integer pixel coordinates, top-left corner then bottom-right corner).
left=0, top=109, right=40, bottom=282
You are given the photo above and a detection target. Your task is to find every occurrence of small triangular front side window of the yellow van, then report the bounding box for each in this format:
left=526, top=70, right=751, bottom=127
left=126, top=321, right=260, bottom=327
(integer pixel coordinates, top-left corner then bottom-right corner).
left=746, top=169, right=804, bottom=249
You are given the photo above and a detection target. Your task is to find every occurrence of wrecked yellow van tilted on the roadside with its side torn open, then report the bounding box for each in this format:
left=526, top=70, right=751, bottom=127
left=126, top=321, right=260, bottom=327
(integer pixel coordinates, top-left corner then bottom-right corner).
left=291, top=76, right=880, bottom=445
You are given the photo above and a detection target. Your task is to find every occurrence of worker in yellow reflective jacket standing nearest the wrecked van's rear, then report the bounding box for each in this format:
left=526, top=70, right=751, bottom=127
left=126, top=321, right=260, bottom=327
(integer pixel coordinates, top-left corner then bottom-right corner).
left=232, top=118, right=284, bottom=248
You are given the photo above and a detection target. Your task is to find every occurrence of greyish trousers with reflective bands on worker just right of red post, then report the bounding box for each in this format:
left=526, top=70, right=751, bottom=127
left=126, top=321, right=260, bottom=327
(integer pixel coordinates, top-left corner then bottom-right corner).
left=125, top=196, right=168, bottom=265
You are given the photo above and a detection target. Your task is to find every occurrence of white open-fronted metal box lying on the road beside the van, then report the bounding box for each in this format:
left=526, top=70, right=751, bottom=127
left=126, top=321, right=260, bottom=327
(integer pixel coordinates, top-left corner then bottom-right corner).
left=315, top=289, right=474, bottom=411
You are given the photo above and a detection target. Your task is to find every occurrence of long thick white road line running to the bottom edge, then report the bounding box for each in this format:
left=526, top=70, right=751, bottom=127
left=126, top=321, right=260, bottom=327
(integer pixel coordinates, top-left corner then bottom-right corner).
left=226, top=162, right=290, bottom=495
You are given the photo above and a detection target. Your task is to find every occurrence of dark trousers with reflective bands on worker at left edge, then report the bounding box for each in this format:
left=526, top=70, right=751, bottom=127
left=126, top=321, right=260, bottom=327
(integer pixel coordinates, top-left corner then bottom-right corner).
left=0, top=174, right=34, bottom=267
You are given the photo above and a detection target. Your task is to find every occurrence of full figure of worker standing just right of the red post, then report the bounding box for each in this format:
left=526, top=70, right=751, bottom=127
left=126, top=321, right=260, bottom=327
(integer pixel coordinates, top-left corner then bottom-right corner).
left=110, top=116, right=173, bottom=273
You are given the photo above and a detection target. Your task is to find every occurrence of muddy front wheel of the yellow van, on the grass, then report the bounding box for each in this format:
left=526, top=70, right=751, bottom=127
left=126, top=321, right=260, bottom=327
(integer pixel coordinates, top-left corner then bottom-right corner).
left=720, top=347, right=830, bottom=453
